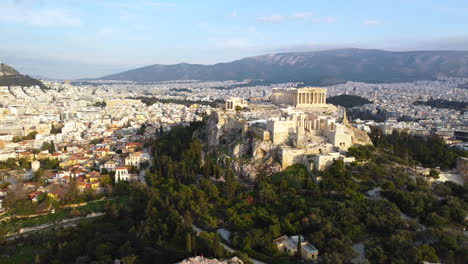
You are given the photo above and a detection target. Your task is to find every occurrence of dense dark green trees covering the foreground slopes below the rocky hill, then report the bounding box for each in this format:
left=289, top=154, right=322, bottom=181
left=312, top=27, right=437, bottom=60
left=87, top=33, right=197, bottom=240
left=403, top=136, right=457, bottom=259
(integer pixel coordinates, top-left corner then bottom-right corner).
left=0, top=123, right=468, bottom=264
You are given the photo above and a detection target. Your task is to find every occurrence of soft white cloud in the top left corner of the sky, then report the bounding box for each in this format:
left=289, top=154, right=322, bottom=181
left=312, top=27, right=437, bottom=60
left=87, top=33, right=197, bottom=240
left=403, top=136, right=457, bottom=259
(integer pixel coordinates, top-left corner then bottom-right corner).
left=0, top=1, right=82, bottom=27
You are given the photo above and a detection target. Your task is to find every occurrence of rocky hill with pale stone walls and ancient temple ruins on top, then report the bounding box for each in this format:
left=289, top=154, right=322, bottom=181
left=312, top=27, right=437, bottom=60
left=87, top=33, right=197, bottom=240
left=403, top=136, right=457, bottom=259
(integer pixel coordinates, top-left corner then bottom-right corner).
left=197, top=87, right=372, bottom=178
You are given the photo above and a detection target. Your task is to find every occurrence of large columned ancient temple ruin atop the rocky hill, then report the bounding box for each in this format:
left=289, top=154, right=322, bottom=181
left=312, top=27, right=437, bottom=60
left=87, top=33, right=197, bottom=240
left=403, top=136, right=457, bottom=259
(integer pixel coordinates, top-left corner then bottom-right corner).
left=271, top=87, right=327, bottom=107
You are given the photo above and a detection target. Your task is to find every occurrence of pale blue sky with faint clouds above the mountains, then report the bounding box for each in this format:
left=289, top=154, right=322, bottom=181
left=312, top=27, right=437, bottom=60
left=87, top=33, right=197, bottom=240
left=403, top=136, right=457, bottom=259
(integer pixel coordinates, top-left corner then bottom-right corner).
left=0, top=0, right=468, bottom=79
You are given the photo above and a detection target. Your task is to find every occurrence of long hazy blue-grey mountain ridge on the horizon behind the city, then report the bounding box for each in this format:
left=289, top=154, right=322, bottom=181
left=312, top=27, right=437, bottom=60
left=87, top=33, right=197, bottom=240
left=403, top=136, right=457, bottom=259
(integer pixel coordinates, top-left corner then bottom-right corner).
left=99, top=49, right=468, bottom=85
